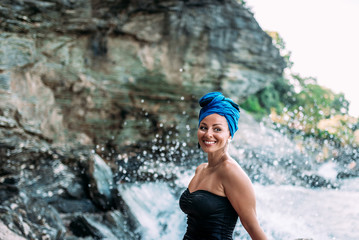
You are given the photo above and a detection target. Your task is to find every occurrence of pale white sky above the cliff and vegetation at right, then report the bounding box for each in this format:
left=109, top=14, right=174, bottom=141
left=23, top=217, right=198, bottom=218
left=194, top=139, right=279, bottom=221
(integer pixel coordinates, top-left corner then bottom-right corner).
left=246, top=0, right=359, bottom=117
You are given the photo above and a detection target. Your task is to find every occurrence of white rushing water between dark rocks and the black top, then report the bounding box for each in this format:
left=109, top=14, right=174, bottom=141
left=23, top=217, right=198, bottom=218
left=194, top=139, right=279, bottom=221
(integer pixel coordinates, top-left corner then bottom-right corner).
left=119, top=183, right=185, bottom=240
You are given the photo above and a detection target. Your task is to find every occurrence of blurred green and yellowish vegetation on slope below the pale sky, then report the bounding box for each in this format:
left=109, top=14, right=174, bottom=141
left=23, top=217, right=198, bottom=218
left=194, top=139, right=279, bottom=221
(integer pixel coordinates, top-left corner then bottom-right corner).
left=241, top=32, right=359, bottom=145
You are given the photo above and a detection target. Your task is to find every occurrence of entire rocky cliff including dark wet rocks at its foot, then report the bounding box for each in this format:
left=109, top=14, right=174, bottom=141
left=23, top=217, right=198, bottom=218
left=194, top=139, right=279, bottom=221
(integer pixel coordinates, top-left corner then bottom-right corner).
left=0, top=0, right=284, bottom=239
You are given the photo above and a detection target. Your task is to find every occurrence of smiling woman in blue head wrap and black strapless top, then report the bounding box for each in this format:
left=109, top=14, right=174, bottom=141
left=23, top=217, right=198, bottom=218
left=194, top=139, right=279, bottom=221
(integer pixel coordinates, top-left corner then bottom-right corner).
left=180, top=92, right=267, bottom=240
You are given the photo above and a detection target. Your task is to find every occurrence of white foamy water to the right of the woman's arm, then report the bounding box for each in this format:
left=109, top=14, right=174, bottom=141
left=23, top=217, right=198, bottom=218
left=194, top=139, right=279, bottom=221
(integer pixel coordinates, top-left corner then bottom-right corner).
left=255, top=182, right=359, bottom=240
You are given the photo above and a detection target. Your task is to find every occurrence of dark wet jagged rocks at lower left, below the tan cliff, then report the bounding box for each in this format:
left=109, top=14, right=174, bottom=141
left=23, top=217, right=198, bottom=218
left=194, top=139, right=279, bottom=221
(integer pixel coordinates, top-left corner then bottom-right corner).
left=0, top=141, right=141, bottom=239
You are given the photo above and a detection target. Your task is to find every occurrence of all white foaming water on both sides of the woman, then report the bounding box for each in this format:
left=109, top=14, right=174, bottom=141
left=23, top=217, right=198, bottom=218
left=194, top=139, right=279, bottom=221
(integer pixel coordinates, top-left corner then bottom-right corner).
left=119, top=178, right=359, bottom=240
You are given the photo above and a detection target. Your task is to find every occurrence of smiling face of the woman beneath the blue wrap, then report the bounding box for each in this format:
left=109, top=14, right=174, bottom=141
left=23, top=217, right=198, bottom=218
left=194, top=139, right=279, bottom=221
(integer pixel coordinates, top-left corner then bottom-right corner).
left=197, top=114, right=231, bottom=153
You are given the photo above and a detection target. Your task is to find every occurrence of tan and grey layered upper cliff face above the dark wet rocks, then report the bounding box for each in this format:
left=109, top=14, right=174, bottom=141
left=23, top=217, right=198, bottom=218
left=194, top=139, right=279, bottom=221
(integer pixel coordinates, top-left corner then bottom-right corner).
left=0, top=0, right=284, bottom=147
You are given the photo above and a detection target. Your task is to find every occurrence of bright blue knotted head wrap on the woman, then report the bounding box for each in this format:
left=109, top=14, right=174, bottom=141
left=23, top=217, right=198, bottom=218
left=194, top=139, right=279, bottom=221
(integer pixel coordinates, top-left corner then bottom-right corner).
left=198, top=92, right=240, bottom=138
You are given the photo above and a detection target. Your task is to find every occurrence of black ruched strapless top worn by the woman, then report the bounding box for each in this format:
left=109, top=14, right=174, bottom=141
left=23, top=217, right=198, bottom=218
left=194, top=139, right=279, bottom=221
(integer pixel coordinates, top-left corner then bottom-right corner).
left=179, top=188, right=238, bottom=240
